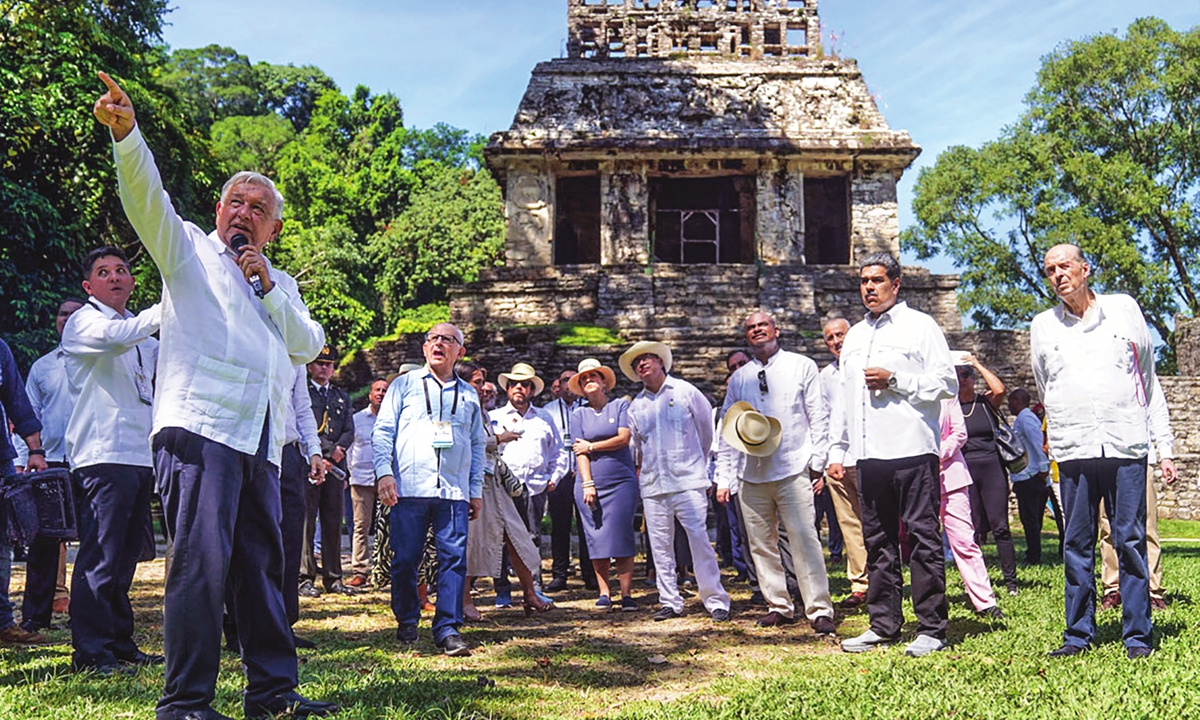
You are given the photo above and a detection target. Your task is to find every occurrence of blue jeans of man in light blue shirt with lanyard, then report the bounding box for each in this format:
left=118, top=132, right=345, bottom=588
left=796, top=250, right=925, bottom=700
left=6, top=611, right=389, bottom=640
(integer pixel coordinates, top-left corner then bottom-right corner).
left=388, top=498, right=467, bottom=642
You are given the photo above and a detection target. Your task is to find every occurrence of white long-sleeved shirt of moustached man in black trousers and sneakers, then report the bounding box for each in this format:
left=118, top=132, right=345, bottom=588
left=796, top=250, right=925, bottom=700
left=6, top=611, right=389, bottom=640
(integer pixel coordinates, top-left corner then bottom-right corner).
left=829, top=301, right=959, bottom=464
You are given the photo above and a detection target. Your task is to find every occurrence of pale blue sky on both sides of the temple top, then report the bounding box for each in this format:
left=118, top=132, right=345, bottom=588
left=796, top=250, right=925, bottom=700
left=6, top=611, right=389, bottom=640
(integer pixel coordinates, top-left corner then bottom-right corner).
left=164, top=0, right=1200, bottom=272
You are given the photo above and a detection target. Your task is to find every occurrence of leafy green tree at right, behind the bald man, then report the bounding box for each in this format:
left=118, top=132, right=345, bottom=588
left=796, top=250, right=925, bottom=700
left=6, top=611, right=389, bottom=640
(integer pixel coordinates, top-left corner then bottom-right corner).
left=901, top=18, right=1200, bottom=362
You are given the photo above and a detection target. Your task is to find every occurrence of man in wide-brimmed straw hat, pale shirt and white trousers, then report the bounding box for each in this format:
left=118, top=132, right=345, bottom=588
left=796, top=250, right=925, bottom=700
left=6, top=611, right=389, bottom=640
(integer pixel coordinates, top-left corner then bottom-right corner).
left=619, top=341, right=730, bottom=622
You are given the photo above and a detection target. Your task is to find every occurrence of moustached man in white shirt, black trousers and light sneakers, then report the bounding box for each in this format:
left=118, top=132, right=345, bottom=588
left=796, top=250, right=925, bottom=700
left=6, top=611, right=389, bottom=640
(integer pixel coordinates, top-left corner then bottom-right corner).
left=829, top=253, right=958, bottom=656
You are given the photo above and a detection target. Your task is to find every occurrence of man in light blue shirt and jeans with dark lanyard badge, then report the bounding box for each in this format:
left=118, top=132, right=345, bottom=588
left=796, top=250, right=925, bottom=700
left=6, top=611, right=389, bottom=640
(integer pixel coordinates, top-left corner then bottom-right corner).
left=372, top=323, right=487, bottom=655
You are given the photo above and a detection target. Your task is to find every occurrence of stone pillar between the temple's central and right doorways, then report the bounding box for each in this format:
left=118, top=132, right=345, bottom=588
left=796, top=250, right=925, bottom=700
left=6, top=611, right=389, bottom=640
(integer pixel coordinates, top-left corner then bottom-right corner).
left=756, top=158, right=804, bottom=265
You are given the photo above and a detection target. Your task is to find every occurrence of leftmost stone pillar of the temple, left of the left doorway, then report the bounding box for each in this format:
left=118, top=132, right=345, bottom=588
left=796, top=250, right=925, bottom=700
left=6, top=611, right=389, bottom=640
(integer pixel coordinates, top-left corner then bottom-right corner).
left=504, top=162, right=554, bottom=268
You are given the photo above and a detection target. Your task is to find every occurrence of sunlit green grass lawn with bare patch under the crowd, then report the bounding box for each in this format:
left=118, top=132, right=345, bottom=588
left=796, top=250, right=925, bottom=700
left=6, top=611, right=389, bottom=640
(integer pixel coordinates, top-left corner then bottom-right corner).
left=0, top=523, right=1200, bottom=720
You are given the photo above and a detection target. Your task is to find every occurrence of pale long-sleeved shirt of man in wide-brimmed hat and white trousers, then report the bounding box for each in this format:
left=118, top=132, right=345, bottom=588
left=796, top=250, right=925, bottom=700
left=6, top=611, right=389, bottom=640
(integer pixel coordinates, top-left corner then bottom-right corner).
left=629, top=376, right=713, bottom=498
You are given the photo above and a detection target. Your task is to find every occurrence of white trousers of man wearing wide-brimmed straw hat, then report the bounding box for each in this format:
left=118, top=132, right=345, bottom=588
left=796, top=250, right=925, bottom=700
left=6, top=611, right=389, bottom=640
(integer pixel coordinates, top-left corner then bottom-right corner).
left=642, top=488, right=730, bottom=612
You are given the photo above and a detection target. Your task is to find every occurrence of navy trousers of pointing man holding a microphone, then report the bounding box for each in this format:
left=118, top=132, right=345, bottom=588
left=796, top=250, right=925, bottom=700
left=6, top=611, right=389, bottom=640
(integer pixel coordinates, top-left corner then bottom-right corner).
left=154, top=427, right=296, bottom=718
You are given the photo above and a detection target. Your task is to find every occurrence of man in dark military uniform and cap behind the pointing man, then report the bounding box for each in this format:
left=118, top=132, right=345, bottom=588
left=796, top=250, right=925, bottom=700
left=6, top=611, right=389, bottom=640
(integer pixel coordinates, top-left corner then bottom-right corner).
left=300, top=346, right=354, bottom=598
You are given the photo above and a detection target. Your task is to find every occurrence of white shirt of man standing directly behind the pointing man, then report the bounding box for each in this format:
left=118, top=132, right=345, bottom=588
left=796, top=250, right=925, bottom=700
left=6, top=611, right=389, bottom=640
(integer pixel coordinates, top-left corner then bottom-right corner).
left=62, top=298, right=161, bottom=469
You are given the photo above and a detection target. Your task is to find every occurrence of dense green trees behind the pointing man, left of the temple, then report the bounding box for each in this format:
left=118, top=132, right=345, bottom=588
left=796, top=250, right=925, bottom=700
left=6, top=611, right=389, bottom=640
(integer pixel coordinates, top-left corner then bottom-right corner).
left=0, top=5, right=504, bottom=367
